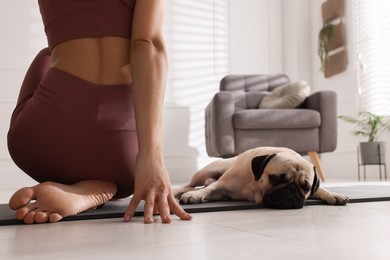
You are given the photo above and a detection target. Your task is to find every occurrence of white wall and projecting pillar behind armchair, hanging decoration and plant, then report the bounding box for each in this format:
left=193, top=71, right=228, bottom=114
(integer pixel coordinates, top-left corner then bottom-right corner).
left=282, top=0, right=390, bottom=180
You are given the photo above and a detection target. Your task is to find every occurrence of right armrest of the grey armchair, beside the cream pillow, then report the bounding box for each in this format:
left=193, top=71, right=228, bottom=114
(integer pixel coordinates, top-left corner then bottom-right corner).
left=303, top=91, right=337, bottom=153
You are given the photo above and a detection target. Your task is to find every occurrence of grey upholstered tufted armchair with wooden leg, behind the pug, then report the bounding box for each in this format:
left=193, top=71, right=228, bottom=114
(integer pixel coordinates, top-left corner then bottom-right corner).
left=205, top=74, right=337, bottom=180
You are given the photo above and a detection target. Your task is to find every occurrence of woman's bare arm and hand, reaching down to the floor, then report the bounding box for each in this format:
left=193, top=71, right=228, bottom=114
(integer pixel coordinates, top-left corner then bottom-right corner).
left=124, top=0, right=191, bottom=223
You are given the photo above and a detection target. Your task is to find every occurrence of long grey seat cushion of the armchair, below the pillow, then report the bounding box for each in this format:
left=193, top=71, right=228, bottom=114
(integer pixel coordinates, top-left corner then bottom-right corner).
left=233, top=109, right=321, bottom=130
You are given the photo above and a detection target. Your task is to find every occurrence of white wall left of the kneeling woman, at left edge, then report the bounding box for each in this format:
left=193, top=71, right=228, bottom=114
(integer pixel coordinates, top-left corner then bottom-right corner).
left=0, top=0, right=46, bottom=190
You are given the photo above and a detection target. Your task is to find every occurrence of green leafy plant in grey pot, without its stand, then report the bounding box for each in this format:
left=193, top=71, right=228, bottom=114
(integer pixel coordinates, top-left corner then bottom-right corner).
left=339, top=110, right=390, bottom=165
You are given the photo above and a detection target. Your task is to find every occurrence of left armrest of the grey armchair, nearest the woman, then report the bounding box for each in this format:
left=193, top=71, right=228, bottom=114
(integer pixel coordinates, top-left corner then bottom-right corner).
left=205, top=91, right=235, bottom=157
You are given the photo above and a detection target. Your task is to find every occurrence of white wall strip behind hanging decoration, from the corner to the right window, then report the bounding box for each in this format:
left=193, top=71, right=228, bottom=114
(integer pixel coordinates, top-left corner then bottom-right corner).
left=308, top=0, right=390, bottom=180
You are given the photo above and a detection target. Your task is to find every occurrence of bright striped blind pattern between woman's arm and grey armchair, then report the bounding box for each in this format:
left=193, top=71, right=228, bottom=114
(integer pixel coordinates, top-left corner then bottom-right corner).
left=165, top=0, right=230, bottom=166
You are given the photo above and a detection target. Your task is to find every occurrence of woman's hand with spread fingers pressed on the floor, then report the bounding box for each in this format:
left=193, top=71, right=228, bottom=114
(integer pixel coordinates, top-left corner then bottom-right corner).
left=124, top=152, right=192, bottom=224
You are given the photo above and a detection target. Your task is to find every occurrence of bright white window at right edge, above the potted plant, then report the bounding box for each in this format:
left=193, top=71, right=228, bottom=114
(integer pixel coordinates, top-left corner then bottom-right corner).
left=355, top=0, right=390, bottom=115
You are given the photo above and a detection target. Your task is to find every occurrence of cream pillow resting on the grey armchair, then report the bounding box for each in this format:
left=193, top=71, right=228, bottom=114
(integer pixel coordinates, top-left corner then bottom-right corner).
left=259, top=81, right=310, bottom=109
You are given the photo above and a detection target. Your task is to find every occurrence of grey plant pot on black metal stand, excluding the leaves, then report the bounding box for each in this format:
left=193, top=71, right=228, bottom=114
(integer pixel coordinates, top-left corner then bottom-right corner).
left=360, top=142, right=386, bottom=165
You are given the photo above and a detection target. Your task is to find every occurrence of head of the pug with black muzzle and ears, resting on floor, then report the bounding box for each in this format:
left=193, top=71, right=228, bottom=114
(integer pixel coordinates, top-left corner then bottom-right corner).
left=251, top=152, right=320, bottom=209
